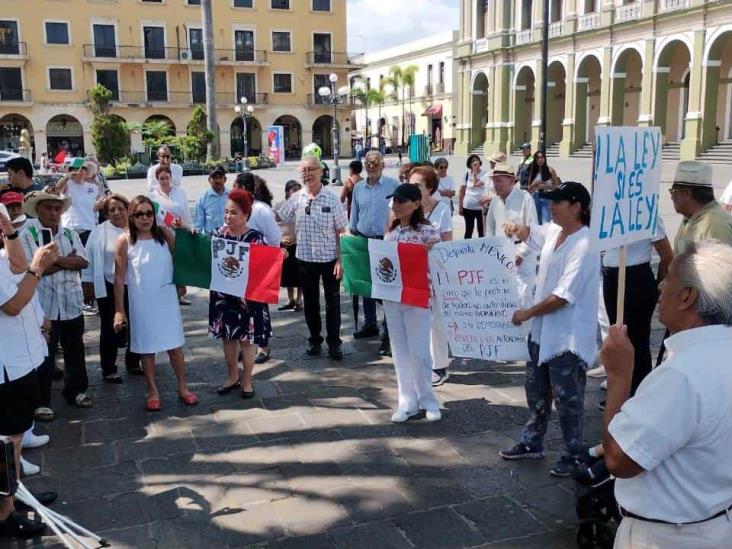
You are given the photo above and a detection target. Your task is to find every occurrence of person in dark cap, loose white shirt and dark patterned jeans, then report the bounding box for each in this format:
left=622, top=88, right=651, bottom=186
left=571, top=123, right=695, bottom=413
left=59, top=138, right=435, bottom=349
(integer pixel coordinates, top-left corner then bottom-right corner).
left=500, top=182, right=600, bottom=477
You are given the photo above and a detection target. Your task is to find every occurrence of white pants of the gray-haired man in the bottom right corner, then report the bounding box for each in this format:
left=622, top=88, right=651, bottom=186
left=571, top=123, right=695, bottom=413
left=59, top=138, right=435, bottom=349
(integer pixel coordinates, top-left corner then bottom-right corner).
left=614, top=515, right=732, bottom=549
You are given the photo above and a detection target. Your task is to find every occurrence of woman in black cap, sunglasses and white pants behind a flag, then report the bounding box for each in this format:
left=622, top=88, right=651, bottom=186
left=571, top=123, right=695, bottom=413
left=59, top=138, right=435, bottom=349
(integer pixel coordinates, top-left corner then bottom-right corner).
left=384, top=183, right=442, bottom=423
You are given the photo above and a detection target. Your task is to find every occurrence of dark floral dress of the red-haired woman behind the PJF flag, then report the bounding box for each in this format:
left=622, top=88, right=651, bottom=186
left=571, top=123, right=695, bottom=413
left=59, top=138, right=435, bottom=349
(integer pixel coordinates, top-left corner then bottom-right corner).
left=208, top=227, right=272, bottom=347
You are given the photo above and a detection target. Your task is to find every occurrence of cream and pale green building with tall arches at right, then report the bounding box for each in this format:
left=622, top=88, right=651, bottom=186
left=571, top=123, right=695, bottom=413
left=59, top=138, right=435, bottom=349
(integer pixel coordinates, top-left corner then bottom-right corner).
left=457, top=0, right=732, bottom=159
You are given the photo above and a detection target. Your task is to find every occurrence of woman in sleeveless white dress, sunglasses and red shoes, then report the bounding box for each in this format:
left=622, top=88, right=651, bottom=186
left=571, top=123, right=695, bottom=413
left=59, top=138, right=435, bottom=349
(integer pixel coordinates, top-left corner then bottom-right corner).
left=114, top=195, right=198, bottom=412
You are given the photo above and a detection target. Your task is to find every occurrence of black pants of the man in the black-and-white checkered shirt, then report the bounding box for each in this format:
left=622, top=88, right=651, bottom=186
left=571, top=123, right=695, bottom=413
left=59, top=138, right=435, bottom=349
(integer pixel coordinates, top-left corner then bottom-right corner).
left=300, top=260, right=341, bottom=348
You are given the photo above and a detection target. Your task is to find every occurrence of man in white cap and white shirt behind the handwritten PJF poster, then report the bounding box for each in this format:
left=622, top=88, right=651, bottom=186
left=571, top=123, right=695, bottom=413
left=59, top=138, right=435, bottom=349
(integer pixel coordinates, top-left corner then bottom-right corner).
left=486, top=162, right=539, bottom=309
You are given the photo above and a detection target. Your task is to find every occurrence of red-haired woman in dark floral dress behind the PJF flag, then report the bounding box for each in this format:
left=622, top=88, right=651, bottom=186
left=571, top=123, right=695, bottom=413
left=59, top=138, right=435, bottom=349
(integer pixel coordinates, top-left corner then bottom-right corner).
left=208, top=189, right=272, bottom=398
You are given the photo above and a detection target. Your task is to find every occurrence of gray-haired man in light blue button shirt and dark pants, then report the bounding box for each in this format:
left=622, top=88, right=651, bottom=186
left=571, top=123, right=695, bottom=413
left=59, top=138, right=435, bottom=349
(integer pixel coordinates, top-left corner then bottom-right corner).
left=348, top=151, right=399, bottom=347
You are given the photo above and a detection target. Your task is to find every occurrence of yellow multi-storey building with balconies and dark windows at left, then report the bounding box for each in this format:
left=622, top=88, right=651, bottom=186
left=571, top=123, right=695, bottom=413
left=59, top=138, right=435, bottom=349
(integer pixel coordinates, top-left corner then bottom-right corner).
left=0, top=0, right=353, bottom=161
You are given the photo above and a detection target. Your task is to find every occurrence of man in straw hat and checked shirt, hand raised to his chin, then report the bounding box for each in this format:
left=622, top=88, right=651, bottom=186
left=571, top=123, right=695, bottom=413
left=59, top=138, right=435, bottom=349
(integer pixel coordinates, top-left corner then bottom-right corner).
left=21, top=187, right=92, bottom=421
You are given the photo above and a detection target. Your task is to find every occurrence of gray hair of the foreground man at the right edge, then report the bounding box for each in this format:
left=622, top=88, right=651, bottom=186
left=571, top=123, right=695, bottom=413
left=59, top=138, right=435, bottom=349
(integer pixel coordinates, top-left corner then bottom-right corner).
left=675, top=239, right=732, bottom=326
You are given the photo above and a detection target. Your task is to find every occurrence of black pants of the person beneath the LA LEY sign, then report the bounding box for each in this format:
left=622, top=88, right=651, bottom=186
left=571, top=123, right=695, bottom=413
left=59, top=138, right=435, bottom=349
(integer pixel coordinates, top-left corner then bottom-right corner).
left=602, top=263, right=658, bottom=395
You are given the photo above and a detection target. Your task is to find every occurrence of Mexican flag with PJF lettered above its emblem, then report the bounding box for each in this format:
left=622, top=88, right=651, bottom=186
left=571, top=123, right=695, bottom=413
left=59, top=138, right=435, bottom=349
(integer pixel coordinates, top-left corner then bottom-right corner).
left=173, top=229, right=283, bottom=303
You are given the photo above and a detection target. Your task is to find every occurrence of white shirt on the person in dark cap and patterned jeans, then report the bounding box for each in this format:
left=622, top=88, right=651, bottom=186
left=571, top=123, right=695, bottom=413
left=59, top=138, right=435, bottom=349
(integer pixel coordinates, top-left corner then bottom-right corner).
left=527, top=223, right=600, bottom=367
